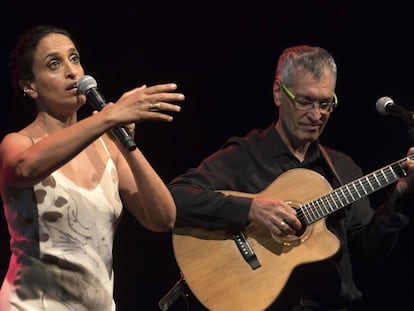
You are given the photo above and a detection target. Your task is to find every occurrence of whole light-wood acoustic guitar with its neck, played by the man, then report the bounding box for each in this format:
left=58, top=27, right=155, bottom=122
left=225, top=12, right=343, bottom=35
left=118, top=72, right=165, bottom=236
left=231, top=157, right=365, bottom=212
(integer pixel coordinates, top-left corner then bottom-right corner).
left=172, top=156, right=414, bottom=311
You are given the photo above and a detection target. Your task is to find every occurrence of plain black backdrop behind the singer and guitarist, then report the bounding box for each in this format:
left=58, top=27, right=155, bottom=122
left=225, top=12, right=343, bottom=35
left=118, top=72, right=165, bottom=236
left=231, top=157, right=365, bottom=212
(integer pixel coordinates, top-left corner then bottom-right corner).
left=0, top=0, right=414, bottom=311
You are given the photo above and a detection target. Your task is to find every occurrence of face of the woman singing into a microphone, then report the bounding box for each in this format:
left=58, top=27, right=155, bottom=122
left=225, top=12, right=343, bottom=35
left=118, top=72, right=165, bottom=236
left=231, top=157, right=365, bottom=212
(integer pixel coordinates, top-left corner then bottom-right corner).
left=25, top=33, right=86, bottom=115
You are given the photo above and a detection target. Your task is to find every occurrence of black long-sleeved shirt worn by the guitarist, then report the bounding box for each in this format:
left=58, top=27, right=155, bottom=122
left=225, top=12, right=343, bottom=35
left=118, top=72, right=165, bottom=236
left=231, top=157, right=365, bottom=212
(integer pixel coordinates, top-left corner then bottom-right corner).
left=168, top=124, right=411, bottom=310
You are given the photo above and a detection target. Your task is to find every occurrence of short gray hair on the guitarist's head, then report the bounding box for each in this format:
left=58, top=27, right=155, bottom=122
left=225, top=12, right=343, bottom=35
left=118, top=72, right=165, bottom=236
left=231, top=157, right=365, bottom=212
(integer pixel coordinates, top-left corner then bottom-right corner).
left=275, top=45, right=337, bottom=85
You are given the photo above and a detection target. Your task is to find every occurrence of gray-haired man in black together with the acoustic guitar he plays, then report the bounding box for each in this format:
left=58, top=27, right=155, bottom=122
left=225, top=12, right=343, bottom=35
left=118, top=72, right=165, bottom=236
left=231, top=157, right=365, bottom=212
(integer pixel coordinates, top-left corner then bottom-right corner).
left=169, top=45, right=414, bottom=311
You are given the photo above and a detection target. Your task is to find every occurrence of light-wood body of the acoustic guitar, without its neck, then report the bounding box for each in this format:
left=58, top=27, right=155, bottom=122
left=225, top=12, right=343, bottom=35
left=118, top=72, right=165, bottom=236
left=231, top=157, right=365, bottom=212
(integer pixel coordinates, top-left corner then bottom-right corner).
left=173, top=169, right=339, bottom=311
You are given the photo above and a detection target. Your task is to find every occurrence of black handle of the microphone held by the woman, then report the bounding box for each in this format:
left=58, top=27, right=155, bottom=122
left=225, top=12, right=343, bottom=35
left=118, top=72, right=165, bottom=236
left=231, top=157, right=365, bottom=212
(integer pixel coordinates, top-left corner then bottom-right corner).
left=85, top=88, right=137, bottom=151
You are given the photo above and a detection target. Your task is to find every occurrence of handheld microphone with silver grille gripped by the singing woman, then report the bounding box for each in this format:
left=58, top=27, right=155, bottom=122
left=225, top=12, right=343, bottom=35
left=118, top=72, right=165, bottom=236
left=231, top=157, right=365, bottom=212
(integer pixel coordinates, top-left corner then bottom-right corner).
left=76, top=75, right=137, bottom=151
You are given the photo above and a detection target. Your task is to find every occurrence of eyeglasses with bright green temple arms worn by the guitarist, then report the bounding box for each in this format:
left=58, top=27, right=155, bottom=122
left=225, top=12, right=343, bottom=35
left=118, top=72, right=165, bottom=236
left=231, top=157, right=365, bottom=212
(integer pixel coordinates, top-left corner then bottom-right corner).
left=279, top=82, right=338, bottom=113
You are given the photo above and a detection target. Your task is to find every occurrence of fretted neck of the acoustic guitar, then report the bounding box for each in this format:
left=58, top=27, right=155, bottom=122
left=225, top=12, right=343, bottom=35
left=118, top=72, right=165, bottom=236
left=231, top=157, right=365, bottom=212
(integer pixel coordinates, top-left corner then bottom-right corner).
left=297, top=156, right=414, bottom=225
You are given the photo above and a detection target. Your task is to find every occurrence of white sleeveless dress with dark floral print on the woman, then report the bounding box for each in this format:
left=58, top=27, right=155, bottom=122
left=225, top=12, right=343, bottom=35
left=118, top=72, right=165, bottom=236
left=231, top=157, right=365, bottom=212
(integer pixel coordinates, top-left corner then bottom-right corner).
left=0, top=141, right=122, bottom=311
